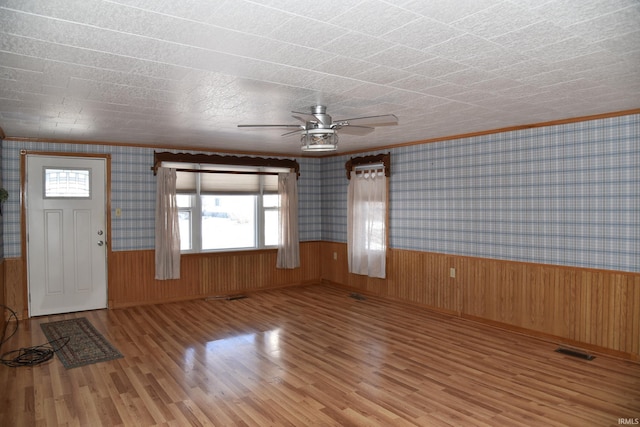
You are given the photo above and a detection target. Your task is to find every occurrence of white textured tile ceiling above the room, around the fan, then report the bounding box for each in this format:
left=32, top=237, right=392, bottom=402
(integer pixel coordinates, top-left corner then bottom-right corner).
left=0, top=0, right=640, bottom=154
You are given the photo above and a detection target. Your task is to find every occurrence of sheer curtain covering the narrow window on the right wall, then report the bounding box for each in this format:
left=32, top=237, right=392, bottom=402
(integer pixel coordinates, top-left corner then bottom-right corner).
left=347, top=171, right=387, bottom=279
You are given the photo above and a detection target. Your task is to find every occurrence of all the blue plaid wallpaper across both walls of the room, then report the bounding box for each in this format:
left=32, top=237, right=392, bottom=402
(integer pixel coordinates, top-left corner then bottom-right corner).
left=1, top=115, right=640, bottom=272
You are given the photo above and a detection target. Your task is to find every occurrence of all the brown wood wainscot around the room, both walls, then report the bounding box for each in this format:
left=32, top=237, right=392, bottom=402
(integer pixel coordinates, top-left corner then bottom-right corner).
left=3, top=242, right=640, bottom=361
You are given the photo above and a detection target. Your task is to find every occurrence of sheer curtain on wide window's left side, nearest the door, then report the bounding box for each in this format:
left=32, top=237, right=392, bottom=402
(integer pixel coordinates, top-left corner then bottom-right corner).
left=156, top=167, right=180, bottom=280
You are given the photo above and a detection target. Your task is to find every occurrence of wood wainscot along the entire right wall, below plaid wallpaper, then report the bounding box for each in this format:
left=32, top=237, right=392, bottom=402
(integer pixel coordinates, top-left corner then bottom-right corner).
left=321, top=242, right=640, bottom=361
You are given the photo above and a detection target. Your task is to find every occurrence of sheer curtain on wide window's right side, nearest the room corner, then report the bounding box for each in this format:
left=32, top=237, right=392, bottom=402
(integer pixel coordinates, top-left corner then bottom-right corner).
left=276, top=172, right=300, bottom=268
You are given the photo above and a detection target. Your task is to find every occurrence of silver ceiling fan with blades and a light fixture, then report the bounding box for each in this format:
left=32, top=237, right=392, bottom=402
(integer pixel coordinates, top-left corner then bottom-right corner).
left=238, top=105, right=398, bottom=151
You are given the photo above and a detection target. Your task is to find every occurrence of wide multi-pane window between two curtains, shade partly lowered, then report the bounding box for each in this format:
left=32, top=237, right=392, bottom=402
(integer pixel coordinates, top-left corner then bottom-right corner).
left=172, top=162, right=289, bottom=252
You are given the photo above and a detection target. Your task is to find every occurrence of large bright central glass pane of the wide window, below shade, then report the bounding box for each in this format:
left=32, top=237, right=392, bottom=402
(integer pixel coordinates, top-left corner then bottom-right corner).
left=201, top=195, right=256, bottom=250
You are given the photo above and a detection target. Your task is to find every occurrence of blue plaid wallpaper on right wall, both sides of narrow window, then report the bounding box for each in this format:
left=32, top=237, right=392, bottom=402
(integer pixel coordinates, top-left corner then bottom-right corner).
left=322, top=115, right=640, bottom=271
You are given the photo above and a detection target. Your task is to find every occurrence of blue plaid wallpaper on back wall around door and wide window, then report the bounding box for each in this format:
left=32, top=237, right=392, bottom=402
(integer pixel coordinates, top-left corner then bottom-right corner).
left=2, top=141, right=321, bottom=258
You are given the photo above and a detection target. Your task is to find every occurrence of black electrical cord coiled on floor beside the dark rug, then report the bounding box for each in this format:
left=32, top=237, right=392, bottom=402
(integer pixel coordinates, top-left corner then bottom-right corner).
left=0, top=304, right=70, bottom=368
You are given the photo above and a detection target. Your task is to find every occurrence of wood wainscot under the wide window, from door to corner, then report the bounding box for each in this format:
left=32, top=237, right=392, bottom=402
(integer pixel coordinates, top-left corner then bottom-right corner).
left=109, top=242, right=320, bottom=308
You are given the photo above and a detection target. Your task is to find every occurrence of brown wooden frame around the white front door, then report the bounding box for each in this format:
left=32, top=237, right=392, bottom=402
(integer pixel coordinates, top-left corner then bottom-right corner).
left=20, top=150, right=112, bottom=319
